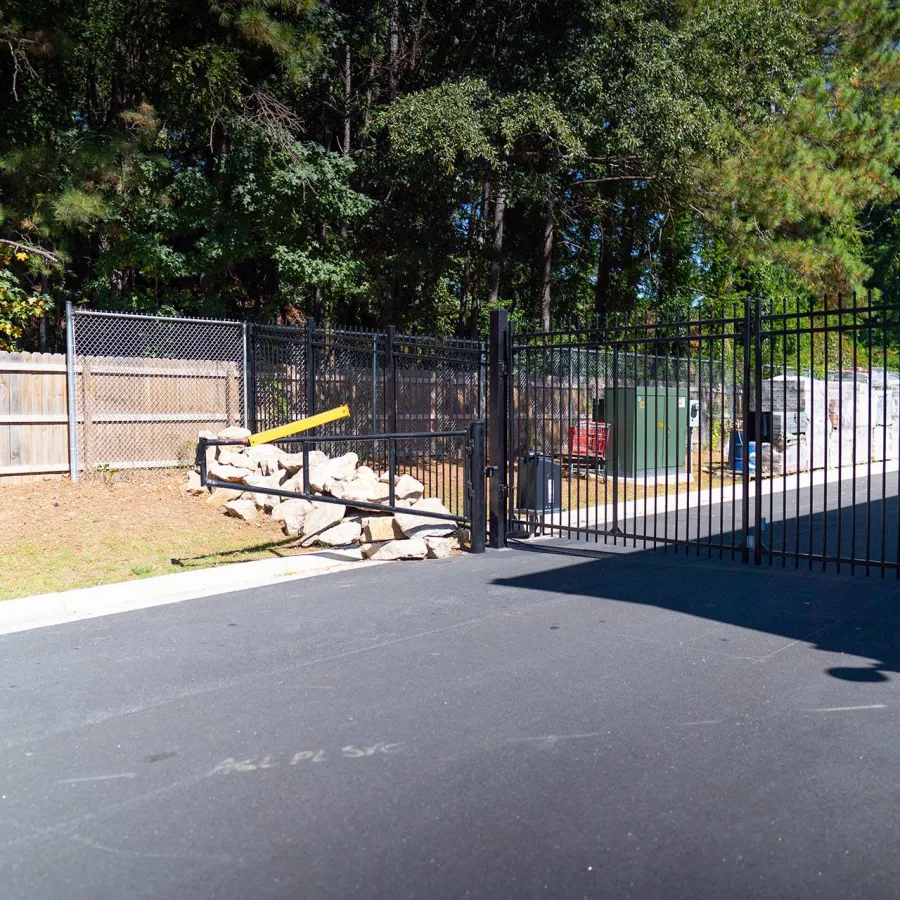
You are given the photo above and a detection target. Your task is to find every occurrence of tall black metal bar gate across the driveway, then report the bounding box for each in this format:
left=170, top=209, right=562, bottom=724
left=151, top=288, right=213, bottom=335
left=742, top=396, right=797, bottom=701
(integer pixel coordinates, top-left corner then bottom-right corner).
left=488, top=297, right=900, bottom=577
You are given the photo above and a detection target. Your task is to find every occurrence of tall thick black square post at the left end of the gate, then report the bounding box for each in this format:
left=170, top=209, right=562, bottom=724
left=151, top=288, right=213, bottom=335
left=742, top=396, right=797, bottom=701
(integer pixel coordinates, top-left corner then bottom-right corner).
left=488, top=309, right=509, bottom=550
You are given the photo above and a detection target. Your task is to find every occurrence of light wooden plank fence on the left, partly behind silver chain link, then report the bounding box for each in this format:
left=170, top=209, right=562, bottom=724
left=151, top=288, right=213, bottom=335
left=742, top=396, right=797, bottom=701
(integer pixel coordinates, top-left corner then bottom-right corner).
left=0, top=352, right=242, bottom=483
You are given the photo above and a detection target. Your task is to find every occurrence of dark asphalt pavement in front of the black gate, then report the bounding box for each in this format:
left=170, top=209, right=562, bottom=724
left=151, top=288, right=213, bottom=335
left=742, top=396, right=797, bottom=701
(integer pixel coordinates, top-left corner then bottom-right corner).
left=0, top=545, right=900, bottom=900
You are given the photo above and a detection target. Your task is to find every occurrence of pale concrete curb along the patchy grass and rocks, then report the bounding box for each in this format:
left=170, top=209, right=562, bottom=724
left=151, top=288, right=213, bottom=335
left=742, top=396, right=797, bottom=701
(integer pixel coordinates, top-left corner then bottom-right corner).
left=0, top=548, right=382, bottom=635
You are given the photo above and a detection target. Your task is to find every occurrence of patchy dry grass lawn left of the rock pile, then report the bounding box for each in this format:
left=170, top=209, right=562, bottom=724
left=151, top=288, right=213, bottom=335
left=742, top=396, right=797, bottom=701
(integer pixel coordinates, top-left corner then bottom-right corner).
left=0, top=471, right=308, bottom=600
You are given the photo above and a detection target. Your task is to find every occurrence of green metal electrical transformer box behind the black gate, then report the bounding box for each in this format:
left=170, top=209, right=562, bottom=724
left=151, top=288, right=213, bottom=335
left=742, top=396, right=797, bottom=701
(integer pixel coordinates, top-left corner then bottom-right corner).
left=603, top=386, right=690, bottom=478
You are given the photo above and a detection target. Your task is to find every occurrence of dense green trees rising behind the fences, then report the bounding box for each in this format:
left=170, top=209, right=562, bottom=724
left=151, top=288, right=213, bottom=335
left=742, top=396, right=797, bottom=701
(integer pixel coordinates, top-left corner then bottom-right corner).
left=0, top=0, right=900, bottom=346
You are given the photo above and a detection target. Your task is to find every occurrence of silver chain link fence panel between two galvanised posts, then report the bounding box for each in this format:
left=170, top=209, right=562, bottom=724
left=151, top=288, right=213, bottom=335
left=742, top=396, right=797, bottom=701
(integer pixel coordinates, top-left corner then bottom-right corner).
left=70, top=309, right=248, bottom=473
